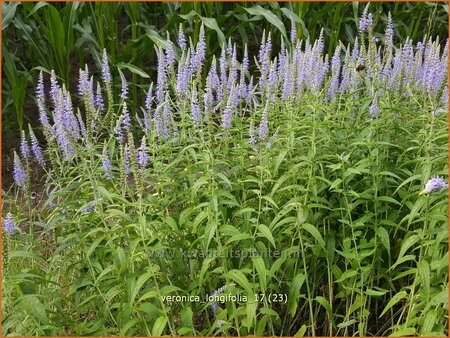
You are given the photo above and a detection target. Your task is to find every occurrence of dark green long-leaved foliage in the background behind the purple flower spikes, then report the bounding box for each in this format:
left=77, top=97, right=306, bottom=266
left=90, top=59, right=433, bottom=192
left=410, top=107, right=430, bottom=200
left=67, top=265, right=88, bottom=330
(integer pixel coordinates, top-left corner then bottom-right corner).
left=2, top=2, right=448, bottom=130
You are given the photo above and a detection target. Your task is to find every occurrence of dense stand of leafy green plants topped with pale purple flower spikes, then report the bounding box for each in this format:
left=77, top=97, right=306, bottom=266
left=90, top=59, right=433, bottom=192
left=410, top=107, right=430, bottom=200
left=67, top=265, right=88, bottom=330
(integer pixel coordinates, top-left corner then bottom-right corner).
left=3, top=7, right=448, bottom=336
